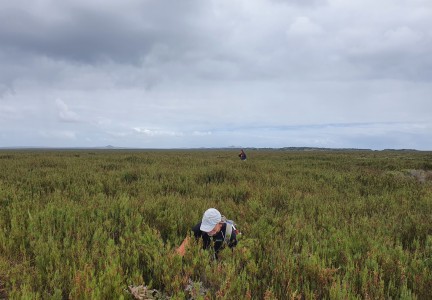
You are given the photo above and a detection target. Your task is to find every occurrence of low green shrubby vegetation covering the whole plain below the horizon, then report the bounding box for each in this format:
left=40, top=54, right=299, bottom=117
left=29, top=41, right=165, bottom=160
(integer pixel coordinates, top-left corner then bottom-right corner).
left=0, top=150, right=432, bottom=299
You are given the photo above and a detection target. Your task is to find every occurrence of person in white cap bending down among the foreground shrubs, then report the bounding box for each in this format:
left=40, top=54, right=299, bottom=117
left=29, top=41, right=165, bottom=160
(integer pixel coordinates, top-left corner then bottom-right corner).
left=176, top=208, right=237, bottom=259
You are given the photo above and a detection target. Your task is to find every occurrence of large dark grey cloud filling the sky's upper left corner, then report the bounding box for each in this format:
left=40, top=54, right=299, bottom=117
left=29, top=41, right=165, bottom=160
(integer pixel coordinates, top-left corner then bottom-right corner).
left=0, top=1, right=204, bottom=63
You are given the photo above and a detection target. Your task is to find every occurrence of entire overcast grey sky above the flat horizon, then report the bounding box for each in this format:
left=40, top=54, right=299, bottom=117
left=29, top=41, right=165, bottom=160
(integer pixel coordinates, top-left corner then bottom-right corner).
left=0, top=0, right=432, bottom=150
